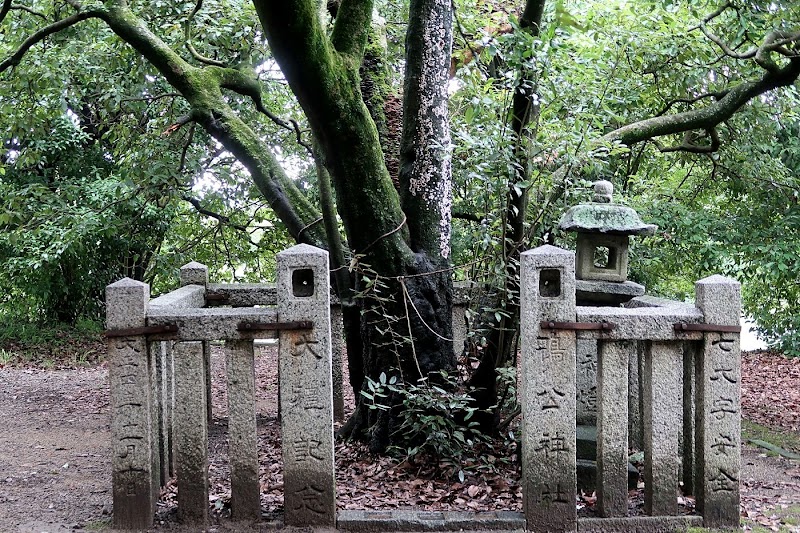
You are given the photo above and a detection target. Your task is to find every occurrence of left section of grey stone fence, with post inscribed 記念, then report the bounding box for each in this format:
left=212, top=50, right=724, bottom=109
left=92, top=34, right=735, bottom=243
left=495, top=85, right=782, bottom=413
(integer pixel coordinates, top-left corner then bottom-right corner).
left=106, top=245, right=336, bottom=529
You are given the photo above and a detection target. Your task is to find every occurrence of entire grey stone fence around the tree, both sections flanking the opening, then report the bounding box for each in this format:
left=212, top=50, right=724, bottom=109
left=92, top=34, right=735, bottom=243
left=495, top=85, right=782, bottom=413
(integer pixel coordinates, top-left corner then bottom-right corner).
left=106, top=245, right=741, bottom=531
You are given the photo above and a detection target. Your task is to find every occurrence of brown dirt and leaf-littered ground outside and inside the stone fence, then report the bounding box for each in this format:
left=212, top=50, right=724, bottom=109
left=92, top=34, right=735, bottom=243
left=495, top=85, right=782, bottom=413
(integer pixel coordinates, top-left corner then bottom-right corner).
left=0, top=349, right=800, bottom=533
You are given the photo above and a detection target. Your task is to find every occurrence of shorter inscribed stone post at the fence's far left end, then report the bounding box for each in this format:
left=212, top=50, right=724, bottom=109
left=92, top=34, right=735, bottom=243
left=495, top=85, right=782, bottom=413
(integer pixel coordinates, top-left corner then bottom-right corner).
left=106, top=278, right=158, bottom=529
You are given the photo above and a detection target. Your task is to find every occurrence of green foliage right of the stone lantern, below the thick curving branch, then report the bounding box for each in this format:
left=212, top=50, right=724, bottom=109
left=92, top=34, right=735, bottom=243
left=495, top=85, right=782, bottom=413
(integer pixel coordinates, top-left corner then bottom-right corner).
left=631, top=89, right=800, bottom=356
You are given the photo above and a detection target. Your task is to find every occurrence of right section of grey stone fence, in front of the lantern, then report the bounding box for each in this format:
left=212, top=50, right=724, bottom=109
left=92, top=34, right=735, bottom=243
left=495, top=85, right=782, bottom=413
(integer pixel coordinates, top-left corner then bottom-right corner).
left=520, top=246, right=741, bottom=531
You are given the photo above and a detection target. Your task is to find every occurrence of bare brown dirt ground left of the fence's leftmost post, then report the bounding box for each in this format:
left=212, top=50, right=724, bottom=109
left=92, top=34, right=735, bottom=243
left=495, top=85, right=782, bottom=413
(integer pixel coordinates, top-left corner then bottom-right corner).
left=0, top=367, right=111, bottom=533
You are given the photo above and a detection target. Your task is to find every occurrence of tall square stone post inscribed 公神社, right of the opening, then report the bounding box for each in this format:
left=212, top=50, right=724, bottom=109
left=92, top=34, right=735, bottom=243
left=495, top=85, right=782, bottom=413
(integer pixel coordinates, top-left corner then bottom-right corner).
left=520, top=246, right=577, bottom=531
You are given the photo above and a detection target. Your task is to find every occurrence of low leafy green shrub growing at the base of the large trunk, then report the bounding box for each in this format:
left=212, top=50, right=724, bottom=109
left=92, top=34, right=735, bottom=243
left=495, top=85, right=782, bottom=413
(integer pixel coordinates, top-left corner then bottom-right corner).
left=361, top=371, right=492, bottom=476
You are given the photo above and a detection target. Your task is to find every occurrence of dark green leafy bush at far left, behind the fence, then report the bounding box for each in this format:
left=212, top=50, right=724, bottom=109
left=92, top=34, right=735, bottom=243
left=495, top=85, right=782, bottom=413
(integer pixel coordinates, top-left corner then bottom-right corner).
left=0, top=117, right=170, bottom=322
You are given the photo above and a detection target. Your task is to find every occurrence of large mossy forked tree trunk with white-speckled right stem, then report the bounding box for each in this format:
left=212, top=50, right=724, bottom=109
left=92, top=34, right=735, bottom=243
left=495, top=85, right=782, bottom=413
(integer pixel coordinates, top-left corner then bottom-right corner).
left=254, top=0, right=455, bottom=451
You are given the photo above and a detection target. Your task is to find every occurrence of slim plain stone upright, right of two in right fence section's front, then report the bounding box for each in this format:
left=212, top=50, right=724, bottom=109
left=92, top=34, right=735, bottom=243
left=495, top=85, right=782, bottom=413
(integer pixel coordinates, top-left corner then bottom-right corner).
left=642, top=341, right=683, bottom=516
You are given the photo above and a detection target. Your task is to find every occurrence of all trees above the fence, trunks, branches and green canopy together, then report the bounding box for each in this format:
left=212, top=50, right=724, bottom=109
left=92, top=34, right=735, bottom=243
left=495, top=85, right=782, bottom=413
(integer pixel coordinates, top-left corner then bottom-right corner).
left=0, top=0, right=800, bottom=449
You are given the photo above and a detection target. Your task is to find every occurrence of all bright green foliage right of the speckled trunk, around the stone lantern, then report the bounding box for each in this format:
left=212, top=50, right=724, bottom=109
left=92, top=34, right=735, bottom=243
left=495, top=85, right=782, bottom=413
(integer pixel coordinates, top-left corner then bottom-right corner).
left=451, top=0, right=800, bottom=355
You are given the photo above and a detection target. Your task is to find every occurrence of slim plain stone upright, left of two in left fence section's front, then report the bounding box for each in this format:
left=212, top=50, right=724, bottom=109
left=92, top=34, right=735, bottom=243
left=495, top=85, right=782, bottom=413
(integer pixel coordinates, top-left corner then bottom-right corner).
left=173, top=341, right=208, bottom=525
